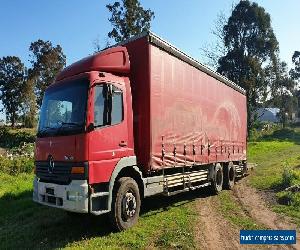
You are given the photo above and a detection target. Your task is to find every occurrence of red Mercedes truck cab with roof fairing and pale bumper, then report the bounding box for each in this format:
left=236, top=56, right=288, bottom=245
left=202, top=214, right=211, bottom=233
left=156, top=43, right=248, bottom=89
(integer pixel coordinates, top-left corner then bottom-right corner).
left=33, top=47, right=141, bottom=230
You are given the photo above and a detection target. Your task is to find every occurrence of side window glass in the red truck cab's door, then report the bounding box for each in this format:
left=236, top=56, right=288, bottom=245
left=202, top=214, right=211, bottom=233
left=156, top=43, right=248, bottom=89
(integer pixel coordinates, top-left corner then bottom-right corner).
left=94, top=84, right=124, bottom=127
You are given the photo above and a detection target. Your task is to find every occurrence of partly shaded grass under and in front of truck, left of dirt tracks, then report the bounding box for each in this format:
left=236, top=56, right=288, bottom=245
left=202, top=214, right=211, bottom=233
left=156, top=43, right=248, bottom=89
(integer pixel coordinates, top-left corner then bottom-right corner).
left=0, top=173, right=196, bottom=249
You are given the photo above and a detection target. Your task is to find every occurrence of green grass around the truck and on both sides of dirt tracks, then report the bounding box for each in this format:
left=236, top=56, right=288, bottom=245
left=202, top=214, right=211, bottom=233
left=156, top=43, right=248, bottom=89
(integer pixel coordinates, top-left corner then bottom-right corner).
left=0, top=129, right=300, bottom=249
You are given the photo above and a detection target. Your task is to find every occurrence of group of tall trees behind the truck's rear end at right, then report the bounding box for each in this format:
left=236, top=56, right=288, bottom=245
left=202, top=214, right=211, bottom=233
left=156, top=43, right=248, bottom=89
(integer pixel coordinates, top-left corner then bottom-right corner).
left=203, top=0, right=300, bottom=131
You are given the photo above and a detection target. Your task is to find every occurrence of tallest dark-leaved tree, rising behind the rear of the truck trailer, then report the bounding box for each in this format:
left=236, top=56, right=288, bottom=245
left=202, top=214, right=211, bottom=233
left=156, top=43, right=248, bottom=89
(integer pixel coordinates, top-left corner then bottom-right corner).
left=218, top=0, right=279, bottom=131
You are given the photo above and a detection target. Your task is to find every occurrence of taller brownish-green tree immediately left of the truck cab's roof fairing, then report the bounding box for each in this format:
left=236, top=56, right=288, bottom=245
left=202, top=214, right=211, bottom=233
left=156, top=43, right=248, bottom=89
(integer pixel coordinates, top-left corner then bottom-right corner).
left=28, top=40, right=66, bottom=107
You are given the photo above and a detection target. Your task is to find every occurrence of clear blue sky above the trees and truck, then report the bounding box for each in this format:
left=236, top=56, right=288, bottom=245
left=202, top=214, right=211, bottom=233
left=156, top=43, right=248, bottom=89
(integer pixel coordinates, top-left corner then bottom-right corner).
left=0, top=0, right=300, bottom=120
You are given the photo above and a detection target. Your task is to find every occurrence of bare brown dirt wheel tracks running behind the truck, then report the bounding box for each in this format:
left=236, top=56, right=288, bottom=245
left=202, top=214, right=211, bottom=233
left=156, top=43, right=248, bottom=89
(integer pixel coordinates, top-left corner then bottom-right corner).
left=196, top=178, right=300, bottom=250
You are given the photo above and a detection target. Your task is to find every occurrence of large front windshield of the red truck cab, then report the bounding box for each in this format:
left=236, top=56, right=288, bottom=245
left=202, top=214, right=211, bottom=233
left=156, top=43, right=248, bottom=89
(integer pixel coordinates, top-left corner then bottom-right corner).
left=37, top=79, right=88, bottom=137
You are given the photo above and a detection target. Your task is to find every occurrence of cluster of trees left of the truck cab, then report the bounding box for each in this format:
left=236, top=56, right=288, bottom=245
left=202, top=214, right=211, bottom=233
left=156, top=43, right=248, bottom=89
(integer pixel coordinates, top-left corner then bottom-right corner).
left=0, top=39, right=66, bottom=127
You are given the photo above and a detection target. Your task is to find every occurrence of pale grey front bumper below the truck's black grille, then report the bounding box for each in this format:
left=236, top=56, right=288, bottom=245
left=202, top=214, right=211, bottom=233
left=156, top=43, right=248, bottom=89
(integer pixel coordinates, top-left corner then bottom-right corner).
left=33, top=177, right=89, bottom=213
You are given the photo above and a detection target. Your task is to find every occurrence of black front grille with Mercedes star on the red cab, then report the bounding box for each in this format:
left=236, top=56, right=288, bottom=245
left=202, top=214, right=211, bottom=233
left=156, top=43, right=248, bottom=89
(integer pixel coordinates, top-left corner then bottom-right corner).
left=35, top=161, right=87, bottom=185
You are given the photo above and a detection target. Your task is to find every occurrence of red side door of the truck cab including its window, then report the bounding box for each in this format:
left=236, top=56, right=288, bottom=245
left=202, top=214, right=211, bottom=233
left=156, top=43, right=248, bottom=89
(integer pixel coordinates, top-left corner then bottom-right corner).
left=89, top=82, right=132, bottom=183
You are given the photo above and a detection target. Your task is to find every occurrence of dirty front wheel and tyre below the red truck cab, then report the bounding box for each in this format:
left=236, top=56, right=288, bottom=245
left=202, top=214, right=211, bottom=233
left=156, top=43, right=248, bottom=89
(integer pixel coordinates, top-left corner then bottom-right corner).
left=110, top=177, right=141, bottom=231
